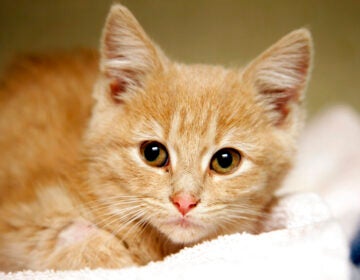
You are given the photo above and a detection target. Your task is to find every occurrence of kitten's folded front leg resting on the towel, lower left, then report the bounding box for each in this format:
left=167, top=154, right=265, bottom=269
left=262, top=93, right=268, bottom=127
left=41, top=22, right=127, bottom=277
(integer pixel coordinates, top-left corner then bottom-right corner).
left=43, top=218, right=138, bottom=270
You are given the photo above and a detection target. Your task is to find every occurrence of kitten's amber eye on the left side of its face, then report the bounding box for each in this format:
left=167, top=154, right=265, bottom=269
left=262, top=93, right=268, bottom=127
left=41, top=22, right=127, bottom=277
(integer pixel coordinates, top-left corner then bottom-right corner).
left=140, top=141, right=169, bottom=167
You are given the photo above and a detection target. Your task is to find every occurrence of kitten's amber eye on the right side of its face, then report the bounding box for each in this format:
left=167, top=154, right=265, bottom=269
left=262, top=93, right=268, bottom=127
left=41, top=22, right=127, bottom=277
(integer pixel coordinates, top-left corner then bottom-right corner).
left=210, top=148, right=241, bottom=174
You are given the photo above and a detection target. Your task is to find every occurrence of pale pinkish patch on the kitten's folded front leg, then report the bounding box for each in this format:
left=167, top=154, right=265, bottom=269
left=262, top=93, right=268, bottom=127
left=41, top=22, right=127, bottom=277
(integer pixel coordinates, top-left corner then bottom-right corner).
left=56, top=219, right=98, bottom=247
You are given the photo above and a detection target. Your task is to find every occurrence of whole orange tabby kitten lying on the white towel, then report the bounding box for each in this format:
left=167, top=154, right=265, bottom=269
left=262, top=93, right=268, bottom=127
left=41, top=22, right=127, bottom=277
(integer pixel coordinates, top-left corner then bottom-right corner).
left=0, top=5, right=312, bottom=271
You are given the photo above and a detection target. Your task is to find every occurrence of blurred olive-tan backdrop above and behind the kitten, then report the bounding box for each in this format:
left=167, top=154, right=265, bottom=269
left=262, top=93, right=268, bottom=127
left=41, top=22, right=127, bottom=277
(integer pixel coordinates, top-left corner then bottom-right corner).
left=0, top=0, right=360, bottom=115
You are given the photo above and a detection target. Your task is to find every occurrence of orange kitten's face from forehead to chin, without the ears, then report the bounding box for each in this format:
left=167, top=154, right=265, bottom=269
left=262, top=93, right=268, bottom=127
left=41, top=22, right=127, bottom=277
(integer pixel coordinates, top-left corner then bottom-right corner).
left=86, top=65, right=292, bottom=243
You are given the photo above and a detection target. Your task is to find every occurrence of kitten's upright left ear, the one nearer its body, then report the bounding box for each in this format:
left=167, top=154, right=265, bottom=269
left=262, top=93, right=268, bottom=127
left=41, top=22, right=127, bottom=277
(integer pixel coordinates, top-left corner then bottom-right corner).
left=100, top=4, right=165, bottom=101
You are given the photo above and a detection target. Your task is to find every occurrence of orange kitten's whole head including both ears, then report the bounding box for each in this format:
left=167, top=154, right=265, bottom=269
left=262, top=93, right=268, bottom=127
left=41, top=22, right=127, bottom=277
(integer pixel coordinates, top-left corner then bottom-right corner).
left=86, top=5, right=312, bottom=243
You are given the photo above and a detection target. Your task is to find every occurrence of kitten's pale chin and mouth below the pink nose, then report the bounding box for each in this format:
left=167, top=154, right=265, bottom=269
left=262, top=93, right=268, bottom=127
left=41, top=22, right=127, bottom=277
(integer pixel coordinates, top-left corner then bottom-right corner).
left=159, top=219, right=209, bottom=244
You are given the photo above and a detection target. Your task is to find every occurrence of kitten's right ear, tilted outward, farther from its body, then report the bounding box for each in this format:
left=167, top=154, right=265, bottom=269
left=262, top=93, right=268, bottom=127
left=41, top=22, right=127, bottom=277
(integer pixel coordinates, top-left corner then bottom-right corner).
left=243, top=29, right=312, bottom=125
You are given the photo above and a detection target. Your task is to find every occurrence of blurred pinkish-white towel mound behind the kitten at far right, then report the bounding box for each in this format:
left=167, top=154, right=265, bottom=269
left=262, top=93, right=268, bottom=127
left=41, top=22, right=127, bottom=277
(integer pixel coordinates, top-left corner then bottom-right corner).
left=280, top=105, right=360, bottom=241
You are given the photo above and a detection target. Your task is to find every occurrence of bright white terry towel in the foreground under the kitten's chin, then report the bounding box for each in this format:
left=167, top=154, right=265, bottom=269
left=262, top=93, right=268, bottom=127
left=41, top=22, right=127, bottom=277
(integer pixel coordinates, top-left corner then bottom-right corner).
left=0, top=193, right=350, bottom=280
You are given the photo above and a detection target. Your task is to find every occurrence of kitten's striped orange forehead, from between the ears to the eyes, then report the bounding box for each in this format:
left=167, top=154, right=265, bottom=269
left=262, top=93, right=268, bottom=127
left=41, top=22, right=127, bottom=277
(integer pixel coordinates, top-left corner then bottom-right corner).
left=134, top=65, right=260, bottom=165
